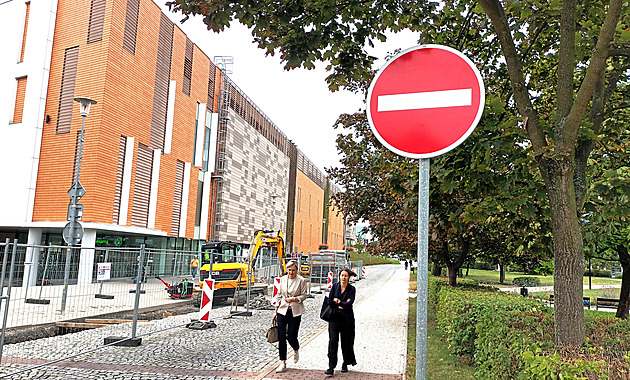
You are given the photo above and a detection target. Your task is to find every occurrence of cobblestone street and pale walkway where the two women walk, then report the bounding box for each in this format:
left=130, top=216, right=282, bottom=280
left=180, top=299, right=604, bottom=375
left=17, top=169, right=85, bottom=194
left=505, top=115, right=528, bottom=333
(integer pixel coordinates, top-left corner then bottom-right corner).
left=0, top=265, right=408, bottom=380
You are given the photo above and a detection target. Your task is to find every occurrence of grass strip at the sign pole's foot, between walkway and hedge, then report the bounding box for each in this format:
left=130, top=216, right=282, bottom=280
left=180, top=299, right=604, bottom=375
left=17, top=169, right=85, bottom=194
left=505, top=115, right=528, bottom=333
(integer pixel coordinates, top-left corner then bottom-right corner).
left=405, top=273, right=475, bottom=380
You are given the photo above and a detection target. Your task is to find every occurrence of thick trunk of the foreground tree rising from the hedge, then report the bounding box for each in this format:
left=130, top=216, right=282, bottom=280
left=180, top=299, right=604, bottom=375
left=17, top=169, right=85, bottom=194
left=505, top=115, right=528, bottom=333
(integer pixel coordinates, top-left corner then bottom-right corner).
left=541, top=160, right=585, bottom=347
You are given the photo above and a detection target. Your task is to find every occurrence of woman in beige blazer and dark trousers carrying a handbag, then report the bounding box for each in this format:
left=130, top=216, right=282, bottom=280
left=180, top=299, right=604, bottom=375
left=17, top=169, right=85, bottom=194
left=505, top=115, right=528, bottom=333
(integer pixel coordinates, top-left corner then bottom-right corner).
left=274, top=261, right=308, bottom=372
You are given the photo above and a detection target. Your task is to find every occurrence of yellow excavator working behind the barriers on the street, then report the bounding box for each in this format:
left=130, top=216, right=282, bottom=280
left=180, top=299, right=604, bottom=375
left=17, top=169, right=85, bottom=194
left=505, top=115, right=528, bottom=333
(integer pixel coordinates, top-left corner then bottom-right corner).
left=193, top=230, right=286, bottom=306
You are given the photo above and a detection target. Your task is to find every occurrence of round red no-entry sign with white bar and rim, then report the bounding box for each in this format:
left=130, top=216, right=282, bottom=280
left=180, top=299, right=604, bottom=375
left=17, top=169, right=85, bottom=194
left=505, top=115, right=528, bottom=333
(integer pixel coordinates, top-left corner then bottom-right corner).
left=367, top=45, right=485, bottom=158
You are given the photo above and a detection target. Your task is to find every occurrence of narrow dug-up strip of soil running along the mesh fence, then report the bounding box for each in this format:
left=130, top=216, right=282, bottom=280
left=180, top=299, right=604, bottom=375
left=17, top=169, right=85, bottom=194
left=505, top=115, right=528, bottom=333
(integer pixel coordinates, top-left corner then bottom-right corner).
left=4, top=302, right=199, bottom=344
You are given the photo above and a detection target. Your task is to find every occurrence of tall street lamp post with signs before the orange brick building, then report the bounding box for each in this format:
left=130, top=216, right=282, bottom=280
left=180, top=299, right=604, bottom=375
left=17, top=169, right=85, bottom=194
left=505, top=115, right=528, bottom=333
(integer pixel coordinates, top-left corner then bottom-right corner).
left=61, top=97, right=96, bottom=313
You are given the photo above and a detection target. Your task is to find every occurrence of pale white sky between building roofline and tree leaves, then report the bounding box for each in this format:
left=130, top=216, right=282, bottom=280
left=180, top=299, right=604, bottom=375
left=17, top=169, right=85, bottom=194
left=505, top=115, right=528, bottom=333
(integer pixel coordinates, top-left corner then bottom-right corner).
left=156, top=0, right=417, bottom=171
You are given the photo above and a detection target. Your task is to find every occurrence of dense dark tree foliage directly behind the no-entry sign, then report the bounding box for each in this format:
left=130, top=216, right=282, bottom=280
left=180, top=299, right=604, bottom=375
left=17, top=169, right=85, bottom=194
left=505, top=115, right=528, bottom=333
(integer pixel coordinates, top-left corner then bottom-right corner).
left=328, top=91, right=548, bottom=285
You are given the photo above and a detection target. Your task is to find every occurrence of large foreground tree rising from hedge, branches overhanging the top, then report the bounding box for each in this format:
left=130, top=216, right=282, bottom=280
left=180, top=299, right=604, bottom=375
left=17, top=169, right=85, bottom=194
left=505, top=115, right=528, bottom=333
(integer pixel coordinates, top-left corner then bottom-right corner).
left=170, top=0, right=630, bottom=345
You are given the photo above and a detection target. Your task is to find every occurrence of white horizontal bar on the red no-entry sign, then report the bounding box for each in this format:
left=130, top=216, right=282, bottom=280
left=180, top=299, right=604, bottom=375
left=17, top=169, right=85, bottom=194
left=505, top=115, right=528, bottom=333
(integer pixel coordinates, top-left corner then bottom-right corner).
left=377, top=88, right=472, bottom=112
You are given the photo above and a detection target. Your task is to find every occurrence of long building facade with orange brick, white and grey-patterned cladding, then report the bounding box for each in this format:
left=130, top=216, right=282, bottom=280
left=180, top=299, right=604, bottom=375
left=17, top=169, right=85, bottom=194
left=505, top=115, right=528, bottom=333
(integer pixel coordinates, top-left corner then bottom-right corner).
left=0, top=0, right=344, bottom=281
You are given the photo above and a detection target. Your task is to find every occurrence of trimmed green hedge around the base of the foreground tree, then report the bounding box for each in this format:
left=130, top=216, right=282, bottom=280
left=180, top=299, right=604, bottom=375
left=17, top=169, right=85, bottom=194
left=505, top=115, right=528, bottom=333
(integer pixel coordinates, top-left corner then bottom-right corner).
left=428, top=277, right=630, bottom=380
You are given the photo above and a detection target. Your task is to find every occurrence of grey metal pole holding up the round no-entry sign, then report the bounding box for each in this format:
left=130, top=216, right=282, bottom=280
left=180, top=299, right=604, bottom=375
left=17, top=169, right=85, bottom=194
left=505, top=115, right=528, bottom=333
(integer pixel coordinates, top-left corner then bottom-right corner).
left=416, top=158, right=431, bottom=380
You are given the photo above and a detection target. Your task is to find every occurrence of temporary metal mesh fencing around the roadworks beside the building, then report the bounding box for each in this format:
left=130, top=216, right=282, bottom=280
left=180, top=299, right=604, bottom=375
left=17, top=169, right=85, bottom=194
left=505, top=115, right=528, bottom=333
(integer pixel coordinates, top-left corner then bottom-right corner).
left=0, top=239, right=362, bottom=378
